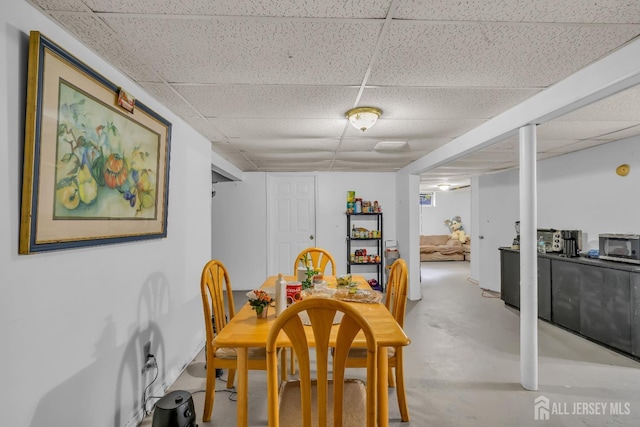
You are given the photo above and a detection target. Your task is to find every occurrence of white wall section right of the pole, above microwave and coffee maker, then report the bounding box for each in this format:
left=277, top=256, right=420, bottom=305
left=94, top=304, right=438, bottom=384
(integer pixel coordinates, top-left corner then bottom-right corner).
left=538, top=137, right=640, bottom=248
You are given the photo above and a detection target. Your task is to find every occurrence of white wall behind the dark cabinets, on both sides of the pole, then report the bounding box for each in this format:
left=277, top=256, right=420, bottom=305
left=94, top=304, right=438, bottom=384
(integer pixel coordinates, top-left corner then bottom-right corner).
left=474, top=137, right=640, bottom=290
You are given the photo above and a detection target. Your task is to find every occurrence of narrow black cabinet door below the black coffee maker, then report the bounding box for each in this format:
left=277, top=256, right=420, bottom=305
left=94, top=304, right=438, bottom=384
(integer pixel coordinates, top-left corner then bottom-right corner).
left=551, top=260, right=583, bottom=332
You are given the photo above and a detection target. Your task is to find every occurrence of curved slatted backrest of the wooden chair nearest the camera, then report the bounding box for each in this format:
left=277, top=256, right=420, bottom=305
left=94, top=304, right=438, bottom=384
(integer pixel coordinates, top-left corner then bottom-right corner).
left=267, top=298, right=378, bottom=427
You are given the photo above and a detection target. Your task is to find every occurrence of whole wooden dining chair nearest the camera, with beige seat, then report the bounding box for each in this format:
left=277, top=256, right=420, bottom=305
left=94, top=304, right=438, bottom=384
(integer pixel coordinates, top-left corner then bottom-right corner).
left=267, top=298, right=377, bottom=427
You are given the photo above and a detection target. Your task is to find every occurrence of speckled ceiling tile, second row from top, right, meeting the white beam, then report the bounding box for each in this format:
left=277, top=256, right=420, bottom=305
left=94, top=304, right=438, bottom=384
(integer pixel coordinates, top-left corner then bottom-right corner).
left=369, top=21, right=640, bottom=88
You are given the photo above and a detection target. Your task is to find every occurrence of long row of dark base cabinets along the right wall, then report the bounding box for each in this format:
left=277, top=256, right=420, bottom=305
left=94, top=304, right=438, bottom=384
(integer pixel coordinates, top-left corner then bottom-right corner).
left=500, top=248, right=640, bottom=357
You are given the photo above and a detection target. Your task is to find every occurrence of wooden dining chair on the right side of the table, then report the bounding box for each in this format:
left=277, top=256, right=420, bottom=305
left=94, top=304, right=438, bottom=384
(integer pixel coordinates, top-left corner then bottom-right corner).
left=347, top=258, right=409, bottom=422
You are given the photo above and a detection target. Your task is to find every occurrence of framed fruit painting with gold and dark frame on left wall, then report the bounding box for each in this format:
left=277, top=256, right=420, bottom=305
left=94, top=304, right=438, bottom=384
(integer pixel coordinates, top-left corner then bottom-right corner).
left=19, top=31, right=171, bottom=254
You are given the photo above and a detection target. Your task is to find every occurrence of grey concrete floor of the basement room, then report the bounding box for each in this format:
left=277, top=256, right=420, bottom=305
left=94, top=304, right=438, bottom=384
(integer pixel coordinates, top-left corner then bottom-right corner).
left=141, top=261, right=640, bottom=427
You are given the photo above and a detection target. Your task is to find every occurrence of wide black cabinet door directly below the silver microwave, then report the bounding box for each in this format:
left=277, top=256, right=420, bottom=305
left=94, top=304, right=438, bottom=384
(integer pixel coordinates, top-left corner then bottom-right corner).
left=580, top=265, right=631, bottom=353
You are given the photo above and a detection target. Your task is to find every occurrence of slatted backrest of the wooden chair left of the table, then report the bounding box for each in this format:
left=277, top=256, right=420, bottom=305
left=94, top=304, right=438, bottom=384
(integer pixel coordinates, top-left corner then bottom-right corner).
left=200, top=260, right=235, bottom=351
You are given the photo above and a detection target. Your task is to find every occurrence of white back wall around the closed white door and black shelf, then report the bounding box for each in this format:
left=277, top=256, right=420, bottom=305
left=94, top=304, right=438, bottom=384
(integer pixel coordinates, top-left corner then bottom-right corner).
left=211, top=172, right=396, bottom=290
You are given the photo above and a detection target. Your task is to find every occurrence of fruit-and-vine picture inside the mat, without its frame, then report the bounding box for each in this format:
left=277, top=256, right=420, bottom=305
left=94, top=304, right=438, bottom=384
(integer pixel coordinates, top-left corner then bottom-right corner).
left=53, top=81, right=160, bottom=219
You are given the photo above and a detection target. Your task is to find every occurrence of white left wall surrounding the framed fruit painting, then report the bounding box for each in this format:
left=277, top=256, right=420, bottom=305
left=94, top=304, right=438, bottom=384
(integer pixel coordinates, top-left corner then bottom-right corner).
left=0, top=1, right=211, bottom=427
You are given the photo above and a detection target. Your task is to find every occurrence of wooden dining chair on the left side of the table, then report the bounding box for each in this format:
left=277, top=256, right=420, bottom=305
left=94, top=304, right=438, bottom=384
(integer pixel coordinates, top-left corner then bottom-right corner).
left=200, top=260, right=284, bottom=422
